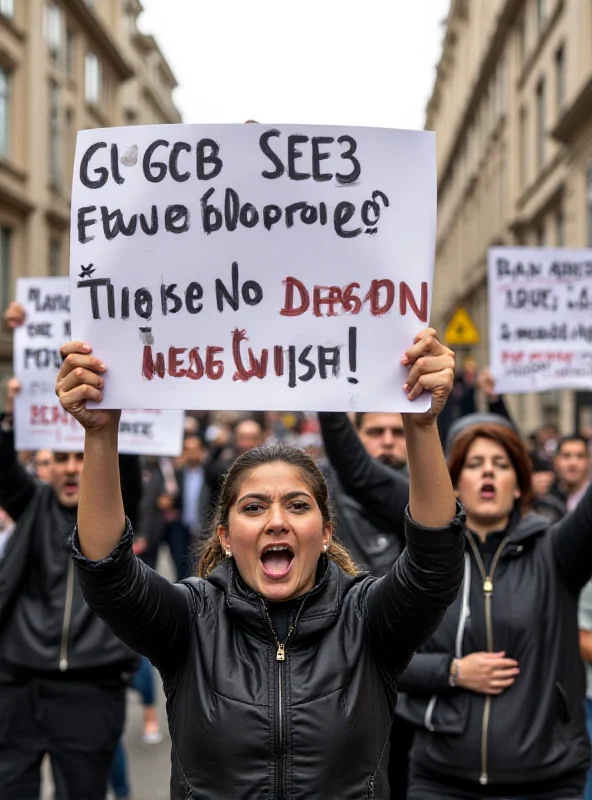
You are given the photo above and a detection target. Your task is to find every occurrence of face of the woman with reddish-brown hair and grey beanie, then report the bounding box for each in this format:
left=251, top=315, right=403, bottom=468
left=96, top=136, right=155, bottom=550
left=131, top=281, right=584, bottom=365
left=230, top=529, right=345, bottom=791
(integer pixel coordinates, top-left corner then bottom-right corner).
left=456, top=439, right=520, bottom=530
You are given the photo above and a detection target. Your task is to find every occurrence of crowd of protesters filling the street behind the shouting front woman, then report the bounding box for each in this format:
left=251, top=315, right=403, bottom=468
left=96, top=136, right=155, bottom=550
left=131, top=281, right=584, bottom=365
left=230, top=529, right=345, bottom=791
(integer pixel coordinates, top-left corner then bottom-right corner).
left=0, top=305, right=592, bottom=800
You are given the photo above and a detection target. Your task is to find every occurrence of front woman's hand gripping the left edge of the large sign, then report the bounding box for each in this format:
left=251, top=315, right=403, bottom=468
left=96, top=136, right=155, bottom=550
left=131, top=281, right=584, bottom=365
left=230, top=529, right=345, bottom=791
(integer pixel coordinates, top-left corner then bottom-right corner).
left=56, top=342, right=121, bottom=433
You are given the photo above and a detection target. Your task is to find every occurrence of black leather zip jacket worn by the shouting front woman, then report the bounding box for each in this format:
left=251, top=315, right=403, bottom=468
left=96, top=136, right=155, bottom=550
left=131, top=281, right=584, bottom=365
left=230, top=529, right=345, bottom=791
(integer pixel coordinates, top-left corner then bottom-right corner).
left=74, top=510, right=464, bottom=800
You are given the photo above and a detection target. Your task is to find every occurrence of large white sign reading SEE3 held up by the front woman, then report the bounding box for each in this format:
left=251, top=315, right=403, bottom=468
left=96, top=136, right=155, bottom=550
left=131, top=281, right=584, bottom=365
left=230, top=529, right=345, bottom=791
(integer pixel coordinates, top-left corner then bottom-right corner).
left=70, top=125, right=436, bottom=411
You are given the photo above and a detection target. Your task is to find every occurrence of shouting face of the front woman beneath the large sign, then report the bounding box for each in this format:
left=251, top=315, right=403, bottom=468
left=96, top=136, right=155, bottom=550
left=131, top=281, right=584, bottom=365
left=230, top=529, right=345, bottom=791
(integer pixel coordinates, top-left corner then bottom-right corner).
left=218, top=462, right=331, bottom=602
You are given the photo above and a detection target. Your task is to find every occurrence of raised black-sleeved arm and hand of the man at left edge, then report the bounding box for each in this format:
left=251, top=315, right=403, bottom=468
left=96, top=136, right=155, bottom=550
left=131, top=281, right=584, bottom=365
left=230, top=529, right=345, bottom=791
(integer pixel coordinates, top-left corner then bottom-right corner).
left=0, top=378, right=36, bottom=522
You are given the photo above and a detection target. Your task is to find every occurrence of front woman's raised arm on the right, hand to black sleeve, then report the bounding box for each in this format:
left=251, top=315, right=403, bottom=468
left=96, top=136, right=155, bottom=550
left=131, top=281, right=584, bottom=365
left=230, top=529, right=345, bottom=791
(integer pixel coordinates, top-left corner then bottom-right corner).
left=366, top=329, right=464, bottom=673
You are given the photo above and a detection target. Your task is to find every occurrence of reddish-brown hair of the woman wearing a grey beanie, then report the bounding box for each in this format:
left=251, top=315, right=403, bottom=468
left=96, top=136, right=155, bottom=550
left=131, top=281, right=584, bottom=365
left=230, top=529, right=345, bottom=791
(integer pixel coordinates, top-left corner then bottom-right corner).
left=448, top=424, right=533, bottom=513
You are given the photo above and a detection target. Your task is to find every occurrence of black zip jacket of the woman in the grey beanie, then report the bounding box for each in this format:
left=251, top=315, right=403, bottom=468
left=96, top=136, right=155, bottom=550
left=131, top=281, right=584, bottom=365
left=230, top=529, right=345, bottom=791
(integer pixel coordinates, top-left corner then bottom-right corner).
left=397, top=488, right=592, bottom=797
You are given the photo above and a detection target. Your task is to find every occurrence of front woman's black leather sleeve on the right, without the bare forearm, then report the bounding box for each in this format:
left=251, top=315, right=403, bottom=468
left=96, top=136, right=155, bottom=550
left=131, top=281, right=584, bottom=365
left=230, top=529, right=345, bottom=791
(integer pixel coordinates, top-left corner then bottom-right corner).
left=365, top=506, right=465, bottom=675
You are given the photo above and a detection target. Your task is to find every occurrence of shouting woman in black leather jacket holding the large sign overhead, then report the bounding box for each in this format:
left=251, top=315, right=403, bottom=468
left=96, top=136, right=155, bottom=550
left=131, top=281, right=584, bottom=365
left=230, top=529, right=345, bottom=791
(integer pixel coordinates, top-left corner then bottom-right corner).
left=57, top=330, right=464, bottom=800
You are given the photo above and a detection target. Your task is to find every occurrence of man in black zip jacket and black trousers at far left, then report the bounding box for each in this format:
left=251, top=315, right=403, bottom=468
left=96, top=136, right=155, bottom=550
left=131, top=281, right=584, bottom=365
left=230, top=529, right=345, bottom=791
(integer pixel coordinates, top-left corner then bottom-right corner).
left=0, top=396, right=137, bottom=800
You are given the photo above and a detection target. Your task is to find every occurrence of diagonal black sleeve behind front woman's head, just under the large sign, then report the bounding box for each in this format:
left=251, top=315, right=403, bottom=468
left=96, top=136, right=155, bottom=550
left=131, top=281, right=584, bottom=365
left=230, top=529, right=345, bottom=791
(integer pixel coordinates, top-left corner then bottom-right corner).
left=319, top=412, right=409, bottom=539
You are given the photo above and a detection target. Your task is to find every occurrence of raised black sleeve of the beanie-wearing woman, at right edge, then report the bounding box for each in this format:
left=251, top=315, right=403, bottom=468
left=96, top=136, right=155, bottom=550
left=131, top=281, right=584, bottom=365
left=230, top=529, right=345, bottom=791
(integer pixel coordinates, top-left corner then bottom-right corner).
left=550, top=483, right=592, bottom=595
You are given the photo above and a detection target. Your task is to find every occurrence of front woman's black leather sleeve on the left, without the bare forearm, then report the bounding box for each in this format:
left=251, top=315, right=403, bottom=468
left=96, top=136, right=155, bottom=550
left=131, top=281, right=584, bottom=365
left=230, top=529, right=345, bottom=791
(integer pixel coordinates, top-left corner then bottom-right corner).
left=72, top=520, right=197, bottom=677
